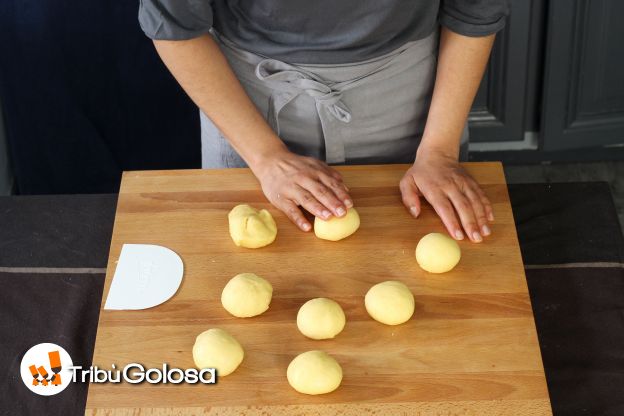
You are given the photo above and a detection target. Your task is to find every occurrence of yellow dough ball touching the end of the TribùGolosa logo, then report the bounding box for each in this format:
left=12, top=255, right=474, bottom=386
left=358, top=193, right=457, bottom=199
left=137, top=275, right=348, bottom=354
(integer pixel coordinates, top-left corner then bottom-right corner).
left=193, top=328, right=245, bottom=377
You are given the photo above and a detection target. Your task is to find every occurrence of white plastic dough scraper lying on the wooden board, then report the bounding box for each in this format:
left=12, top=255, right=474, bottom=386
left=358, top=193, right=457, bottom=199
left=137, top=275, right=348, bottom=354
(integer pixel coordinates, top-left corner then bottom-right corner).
left=104, top=244, right=184, bottom=310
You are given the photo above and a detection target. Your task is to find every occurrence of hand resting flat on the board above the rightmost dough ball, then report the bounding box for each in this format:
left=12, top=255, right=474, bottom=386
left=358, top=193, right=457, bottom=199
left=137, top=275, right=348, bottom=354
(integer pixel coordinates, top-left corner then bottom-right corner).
left=399, top=151, right=494, bottom=243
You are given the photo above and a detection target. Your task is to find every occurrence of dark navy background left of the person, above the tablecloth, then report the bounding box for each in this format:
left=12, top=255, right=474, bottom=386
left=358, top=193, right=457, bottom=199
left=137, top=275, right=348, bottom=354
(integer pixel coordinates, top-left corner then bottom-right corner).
left=0, top=0, right=200, bottom=194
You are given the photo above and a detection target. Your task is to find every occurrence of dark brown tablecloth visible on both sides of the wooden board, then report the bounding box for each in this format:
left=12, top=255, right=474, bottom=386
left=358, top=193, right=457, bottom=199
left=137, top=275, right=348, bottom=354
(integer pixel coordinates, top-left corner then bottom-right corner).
left=0, top=183, right=624, bottom=416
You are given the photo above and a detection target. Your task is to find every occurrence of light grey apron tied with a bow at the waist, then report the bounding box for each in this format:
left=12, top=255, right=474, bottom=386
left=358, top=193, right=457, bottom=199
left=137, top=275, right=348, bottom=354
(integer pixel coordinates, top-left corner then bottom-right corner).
left=201, top=31, right=468, bottom=168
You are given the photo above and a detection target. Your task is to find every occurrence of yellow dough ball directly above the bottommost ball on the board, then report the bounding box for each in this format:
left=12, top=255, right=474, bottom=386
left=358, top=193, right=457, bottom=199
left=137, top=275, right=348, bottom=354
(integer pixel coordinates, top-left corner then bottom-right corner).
left=297, top=298, right=345, bottom=339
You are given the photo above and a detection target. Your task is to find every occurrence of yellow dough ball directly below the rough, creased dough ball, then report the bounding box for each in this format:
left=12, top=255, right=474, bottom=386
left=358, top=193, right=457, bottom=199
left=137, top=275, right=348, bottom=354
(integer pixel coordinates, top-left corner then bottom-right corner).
left=221, top=273, right=273, bottom=318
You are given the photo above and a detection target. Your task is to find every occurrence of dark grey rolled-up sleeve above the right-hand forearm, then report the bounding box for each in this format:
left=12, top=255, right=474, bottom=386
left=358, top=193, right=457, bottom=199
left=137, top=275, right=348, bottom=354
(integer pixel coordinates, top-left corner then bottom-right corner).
left=439, top=0, right=509, bottom=36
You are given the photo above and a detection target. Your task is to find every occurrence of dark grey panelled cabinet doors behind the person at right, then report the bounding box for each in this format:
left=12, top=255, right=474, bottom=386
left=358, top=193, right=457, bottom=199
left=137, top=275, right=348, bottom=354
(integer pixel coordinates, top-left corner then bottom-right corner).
left=471, top=0, right=624, bottom=162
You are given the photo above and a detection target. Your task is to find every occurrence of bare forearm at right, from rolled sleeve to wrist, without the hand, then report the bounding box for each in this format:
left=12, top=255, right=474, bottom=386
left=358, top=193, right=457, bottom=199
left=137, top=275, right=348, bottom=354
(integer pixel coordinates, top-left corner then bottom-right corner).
left=418, top=27, right=495, bottom=158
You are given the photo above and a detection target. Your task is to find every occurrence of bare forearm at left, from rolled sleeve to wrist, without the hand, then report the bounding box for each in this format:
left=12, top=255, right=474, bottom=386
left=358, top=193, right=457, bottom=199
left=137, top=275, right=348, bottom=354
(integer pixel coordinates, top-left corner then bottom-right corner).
left=154, top=35, right=286, bottom=169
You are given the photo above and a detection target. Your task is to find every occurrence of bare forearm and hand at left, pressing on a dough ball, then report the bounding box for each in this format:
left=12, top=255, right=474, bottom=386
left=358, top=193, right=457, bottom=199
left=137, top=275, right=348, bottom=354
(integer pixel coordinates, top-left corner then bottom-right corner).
left=154, top=34, right=353, bottom=231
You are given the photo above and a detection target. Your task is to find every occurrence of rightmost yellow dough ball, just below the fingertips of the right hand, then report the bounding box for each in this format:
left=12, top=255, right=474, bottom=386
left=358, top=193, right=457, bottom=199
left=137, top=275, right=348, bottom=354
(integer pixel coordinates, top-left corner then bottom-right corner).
left=416, top=233, right=461, bottom=273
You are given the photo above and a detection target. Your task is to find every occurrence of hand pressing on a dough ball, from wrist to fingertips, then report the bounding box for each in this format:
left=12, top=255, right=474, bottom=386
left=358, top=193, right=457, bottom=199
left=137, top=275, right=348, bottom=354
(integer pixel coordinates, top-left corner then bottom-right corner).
left=254, top=150, right=353, bottom=231
